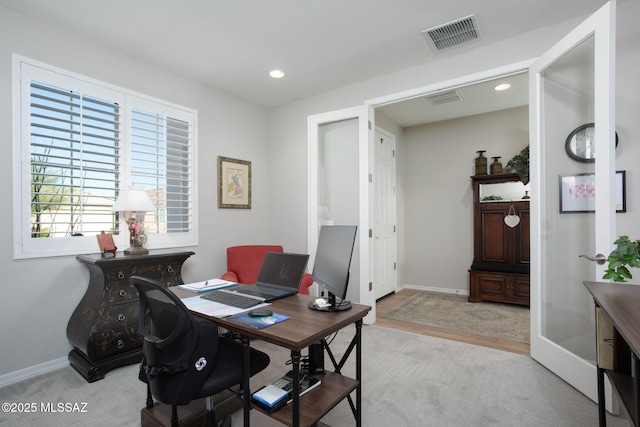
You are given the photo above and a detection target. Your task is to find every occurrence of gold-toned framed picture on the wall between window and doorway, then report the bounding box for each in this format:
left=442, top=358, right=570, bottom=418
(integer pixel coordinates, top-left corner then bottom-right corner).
left=218, top=156, right=251, bottom=209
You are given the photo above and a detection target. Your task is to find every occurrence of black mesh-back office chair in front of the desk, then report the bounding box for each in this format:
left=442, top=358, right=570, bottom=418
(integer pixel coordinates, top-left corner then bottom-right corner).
left=131, top=276, right=269, bottom=426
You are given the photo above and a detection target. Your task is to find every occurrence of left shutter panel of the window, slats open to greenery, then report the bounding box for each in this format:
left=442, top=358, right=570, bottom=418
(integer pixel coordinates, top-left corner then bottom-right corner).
left=30, top=81, right=120, bottom=238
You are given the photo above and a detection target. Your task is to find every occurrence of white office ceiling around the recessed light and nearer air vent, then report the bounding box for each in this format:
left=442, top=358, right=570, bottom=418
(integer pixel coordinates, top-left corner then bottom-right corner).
left=0, top=0, right=605, bottom=126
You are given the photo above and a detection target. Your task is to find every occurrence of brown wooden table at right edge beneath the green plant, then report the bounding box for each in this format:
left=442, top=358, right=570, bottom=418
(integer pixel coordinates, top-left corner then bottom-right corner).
left=584, top=282, right=640, bottom=427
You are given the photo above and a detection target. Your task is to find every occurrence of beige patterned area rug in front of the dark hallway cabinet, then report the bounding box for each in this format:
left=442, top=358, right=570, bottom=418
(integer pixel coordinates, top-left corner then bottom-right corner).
left=382, top=292, right=529, bottom=344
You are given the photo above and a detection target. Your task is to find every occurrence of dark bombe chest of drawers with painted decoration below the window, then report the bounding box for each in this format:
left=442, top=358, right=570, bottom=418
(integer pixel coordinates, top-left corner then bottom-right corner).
left=67, top=251, right=194, bottom=382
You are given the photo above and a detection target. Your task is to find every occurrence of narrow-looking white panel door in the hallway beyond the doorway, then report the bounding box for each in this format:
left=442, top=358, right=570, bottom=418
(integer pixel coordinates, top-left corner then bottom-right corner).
left=371, top=129, right=397, bottom=300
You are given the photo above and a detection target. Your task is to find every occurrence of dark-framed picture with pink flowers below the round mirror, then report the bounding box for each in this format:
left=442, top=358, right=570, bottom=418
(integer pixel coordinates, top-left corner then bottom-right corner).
left=560, top=171, right=627, bottom=213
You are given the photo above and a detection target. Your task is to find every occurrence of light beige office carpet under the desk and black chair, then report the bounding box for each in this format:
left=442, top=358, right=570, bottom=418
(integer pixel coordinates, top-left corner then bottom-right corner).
left=0, top=326, right=630, bottom=427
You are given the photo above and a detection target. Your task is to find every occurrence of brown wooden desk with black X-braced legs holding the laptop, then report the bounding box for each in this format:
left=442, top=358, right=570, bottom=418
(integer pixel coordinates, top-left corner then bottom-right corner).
left=173, top=289, right=371, bottom=426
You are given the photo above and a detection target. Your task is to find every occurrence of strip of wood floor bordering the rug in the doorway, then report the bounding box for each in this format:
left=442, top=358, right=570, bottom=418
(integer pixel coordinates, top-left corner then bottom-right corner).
left=376, top=289, right=530, bottom=355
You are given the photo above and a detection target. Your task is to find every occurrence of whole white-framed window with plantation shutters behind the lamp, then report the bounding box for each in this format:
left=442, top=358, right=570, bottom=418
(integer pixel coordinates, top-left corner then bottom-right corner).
left=14, top=56, right=197, bottom=258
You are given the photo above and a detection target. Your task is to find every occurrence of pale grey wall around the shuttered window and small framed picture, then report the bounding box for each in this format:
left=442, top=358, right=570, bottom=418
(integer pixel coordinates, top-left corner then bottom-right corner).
left=0, top=7, right=272, bottom=376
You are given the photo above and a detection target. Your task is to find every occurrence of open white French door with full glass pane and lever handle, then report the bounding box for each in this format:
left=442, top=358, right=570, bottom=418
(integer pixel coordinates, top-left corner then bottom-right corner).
left=529, top=2, right=615, bottom=402
